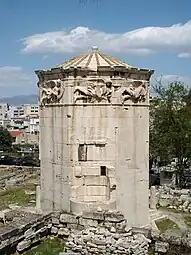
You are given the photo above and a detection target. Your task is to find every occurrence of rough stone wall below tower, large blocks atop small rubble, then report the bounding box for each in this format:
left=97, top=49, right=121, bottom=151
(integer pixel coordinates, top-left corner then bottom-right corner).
left=51, top=210, right=150, bottom=255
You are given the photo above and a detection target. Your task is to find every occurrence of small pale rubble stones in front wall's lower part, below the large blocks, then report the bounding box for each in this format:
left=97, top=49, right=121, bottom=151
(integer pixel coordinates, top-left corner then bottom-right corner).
left=66, top=227, right=150, bottom=255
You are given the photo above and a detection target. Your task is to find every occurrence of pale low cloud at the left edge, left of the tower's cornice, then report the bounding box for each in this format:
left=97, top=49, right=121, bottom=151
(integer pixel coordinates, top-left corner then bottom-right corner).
left=0, top=66, right=32, bottom=87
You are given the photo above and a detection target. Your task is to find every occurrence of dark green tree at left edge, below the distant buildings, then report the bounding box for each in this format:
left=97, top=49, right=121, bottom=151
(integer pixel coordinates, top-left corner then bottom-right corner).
left=0, top=126, right=13, bottom=151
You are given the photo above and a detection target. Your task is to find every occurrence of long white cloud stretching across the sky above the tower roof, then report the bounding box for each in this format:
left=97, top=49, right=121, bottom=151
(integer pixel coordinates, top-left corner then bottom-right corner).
left=21, top=21, right=191, bottom=57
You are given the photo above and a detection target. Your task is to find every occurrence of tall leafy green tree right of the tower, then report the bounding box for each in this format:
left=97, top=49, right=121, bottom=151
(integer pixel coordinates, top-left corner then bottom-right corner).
left=150, top=82, right=191, bottom=187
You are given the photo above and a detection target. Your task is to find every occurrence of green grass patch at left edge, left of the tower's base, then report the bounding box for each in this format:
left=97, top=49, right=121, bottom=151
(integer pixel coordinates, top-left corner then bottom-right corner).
left=0, top=185, right=36, bottom=210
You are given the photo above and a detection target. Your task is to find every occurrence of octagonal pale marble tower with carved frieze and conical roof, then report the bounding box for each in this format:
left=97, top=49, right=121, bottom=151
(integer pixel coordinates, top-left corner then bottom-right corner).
left=36, top=47, right=153, bottom=227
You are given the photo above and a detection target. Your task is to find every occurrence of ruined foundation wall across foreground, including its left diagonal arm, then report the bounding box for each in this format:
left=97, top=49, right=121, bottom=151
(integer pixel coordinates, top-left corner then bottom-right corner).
left=0, top=211, right=150, bottom=255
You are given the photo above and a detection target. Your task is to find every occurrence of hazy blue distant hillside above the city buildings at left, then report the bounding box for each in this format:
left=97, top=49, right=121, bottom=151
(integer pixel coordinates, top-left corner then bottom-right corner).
left=0, top=95, right=37, bottom=105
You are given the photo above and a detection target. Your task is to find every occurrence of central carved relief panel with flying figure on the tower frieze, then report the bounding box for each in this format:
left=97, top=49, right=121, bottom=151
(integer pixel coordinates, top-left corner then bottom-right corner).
left=74, top=80, right=113, bottom=103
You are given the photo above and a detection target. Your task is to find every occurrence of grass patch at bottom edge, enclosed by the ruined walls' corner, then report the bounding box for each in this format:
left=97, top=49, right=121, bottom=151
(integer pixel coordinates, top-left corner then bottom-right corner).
left=14, top=238, right=65, bottom=255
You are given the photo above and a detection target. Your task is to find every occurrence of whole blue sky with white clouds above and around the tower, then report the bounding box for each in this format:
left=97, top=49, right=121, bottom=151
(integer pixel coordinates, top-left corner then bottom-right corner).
left=0, top=0, right=191, bottom=97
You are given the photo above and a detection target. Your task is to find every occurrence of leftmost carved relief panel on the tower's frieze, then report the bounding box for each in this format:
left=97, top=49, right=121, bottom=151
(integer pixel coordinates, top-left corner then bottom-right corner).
left=39, top=79, right=64, bottom=106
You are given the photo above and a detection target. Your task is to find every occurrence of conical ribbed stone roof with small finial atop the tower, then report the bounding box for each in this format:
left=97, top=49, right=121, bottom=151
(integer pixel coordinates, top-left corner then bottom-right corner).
left=57, top=46, right=133, bottom=71
